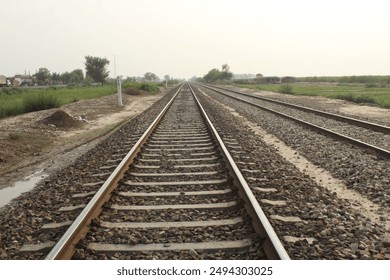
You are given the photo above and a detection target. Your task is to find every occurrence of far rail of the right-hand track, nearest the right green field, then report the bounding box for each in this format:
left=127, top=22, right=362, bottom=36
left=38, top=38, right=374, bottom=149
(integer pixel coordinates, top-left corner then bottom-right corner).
left=202, top=84, right=390, bottom=134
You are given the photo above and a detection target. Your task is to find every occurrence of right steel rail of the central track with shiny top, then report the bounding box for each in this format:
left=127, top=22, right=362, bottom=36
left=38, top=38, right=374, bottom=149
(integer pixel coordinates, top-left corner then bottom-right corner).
left=190, top=85, right=290, bottom=260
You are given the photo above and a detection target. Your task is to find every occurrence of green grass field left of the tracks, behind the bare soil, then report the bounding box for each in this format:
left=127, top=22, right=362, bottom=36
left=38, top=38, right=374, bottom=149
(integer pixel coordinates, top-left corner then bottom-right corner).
left=0, top=85, right=116, bottom=118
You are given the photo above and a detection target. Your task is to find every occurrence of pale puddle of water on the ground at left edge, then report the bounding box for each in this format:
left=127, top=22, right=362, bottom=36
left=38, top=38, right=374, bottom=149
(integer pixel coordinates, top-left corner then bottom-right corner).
left=0, top=170, right=48, bottom=208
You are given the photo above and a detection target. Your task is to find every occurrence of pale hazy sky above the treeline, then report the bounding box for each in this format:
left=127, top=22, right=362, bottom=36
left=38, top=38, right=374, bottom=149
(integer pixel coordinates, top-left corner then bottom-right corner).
left=0, top=0, right=390, bottom=78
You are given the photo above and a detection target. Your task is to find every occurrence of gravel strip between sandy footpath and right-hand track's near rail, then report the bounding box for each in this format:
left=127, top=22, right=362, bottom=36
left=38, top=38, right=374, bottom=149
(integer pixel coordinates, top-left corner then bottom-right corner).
left=200, top=87, right=390, bottom=208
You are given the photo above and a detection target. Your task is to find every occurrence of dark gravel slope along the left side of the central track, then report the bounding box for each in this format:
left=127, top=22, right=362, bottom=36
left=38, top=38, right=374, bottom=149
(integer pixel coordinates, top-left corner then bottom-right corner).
left=0, top=88, right=178, bottom=260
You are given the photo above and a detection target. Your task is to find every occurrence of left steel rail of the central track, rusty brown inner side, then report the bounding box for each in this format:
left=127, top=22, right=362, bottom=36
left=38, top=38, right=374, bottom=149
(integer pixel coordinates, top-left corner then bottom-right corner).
left=45, top=84, right=184, bottom=260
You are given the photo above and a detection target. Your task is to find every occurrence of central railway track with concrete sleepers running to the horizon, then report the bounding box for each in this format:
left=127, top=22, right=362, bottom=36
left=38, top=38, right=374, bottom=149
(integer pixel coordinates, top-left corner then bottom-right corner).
left=21, top=85, right=289, bottom=259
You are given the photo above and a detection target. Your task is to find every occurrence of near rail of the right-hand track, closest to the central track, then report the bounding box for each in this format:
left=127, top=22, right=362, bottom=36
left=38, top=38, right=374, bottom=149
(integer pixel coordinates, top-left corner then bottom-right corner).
left=199, top=83, right=390, bottom=158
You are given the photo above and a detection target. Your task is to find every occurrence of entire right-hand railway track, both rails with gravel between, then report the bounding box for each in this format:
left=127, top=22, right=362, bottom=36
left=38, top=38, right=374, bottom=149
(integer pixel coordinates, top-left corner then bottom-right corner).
left=201, top=85, right=390, bottom=158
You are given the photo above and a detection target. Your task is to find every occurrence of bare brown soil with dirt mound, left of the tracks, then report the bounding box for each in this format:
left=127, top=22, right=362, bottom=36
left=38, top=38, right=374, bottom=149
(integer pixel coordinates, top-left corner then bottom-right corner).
left=0, top=93, right=164, bottom=189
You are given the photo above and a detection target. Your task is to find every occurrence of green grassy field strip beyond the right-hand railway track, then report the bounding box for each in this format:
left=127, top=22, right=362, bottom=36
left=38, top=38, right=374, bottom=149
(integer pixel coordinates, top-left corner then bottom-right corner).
left=236, top=82, right=390, bottom=108
